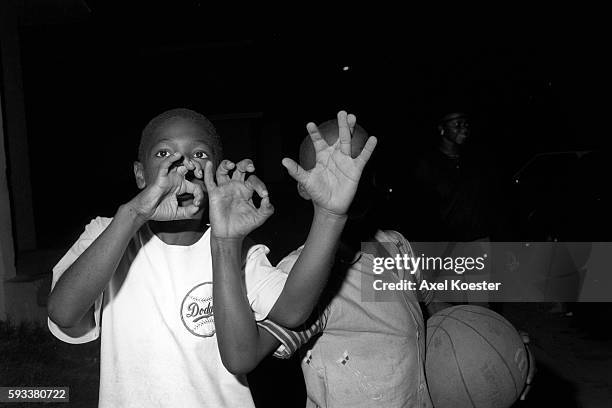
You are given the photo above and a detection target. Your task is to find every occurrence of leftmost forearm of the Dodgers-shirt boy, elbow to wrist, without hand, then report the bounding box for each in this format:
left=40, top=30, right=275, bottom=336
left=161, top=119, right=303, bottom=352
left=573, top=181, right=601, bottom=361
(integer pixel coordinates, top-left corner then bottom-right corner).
left=48, top=204, right=144, bottom=328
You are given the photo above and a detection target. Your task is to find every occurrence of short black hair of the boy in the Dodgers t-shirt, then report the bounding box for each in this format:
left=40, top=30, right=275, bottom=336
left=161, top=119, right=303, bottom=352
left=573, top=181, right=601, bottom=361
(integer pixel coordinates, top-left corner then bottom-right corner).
left=138, top=108, right=223, bottom=167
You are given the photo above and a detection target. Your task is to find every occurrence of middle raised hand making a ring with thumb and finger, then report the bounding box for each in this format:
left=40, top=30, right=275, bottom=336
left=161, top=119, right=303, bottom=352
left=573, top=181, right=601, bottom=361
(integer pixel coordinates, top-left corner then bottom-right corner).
left=204, top=159, right=274, bottom=239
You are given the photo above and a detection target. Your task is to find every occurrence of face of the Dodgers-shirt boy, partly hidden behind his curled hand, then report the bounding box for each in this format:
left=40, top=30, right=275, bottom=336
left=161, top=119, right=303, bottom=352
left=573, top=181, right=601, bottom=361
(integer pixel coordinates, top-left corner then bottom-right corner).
left=134, top=119, right=214, bottom=217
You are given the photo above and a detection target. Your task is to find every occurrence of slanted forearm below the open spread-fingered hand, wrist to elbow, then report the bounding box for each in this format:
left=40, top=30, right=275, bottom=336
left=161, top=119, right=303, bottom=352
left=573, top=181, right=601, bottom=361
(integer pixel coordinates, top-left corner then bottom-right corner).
left=269, top=206, right=347, bottom=327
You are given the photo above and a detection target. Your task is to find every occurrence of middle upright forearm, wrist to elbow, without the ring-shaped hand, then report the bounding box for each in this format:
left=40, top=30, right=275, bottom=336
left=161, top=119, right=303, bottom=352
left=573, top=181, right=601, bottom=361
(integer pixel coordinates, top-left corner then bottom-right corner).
left=211, top=237, right=259, bottom=374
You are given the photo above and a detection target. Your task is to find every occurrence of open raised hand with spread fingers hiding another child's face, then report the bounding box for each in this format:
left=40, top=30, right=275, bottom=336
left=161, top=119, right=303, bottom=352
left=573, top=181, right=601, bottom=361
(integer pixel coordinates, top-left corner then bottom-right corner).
left=282, top=111, right=377, bottom=215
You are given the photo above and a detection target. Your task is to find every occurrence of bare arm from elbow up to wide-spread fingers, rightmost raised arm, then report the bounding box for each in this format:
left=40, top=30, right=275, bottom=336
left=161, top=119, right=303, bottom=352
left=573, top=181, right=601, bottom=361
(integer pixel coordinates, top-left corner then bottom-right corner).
left=269, top=111, right=376, bottom=328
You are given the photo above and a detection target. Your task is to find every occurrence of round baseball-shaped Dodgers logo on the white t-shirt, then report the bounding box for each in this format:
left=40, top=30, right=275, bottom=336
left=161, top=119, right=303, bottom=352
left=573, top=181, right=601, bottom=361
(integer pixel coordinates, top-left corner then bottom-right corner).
left=181, top=282, right=215, bottom=337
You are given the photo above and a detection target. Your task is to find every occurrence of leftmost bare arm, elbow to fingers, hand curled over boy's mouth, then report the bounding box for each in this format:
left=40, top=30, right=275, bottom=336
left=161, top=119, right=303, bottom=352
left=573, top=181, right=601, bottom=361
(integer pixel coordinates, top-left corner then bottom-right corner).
left=47, top=154, right=203, bottom=336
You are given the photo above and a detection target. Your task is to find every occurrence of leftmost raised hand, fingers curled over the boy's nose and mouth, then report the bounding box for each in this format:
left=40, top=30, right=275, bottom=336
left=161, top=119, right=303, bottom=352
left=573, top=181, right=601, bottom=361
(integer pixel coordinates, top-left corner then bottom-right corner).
left=133, top=153, right=204, bottom=221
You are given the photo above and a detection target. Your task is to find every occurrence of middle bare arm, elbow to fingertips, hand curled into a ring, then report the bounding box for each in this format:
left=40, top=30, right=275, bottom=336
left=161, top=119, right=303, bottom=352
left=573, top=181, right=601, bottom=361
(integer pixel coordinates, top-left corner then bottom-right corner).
left=204, top=159, right=274, bottom=374
